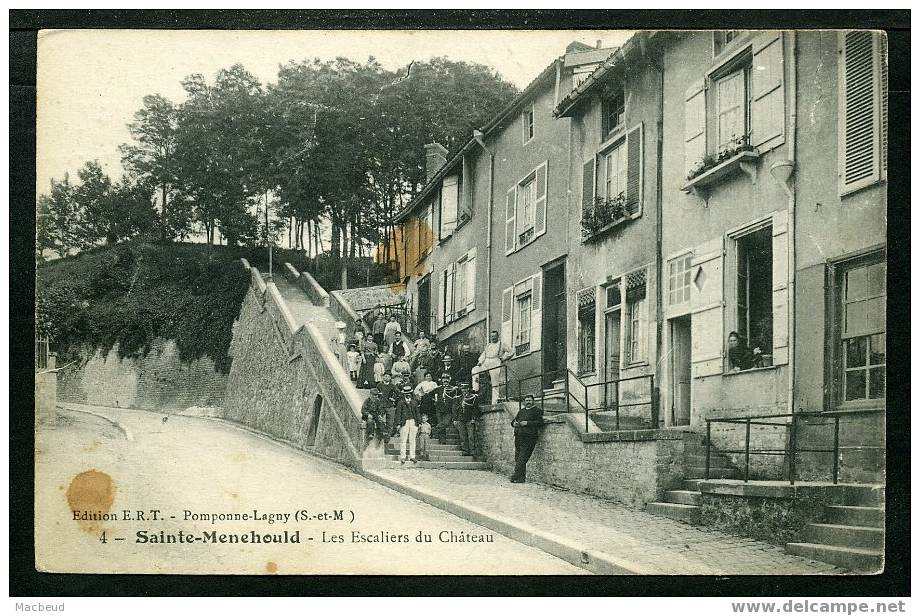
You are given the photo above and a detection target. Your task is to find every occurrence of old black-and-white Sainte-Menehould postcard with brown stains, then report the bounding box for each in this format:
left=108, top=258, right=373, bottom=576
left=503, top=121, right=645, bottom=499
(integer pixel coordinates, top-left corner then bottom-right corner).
left=34, top=29, right=888, bottom=576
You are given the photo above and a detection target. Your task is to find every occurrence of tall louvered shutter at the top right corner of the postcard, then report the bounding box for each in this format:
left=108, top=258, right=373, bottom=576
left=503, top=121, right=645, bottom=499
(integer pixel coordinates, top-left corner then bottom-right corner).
left=837, top=31, right=881, bottom=195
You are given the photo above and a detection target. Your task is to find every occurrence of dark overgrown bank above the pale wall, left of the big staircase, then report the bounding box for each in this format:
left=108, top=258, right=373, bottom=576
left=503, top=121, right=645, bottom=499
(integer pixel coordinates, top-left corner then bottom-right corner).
left=35, top=242, right=249, bottom=372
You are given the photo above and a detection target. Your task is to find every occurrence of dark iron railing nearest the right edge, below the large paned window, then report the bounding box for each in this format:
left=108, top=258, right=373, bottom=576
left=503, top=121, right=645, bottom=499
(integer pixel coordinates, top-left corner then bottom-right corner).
left=706, top=411, right=852, bottom=485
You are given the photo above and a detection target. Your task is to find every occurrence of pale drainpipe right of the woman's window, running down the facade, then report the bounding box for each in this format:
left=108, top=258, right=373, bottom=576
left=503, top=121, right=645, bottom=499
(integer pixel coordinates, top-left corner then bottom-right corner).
left=770, top=31, right=798, bottom=414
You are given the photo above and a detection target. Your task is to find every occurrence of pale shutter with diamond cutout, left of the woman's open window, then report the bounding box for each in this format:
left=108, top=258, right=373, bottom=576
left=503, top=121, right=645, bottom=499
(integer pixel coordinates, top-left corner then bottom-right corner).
left=690, top=236, right=725, bottom=378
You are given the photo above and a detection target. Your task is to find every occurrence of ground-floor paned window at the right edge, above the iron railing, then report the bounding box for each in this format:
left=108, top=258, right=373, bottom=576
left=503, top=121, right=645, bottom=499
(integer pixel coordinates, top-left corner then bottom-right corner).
left=836, top=256, right=887, bottom=404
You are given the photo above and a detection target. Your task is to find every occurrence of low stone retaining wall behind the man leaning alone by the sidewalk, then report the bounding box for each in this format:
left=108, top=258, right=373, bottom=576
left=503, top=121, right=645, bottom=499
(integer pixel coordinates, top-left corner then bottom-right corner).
left=477, top=406, right=684, bottom=508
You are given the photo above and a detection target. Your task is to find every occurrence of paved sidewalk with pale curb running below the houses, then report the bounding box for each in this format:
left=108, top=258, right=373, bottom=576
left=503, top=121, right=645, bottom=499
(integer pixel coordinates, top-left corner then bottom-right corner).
left=364, top=468, right=843, bottom=575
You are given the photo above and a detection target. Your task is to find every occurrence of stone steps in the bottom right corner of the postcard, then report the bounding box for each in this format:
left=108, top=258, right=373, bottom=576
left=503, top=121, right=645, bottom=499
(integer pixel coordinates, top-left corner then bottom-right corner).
left=786, top=486, right=885, bottom=573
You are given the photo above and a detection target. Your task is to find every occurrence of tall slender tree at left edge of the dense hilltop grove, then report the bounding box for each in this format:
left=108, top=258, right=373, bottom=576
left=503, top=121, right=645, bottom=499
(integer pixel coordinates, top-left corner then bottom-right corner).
left=119, top=94, right=181, bottom=239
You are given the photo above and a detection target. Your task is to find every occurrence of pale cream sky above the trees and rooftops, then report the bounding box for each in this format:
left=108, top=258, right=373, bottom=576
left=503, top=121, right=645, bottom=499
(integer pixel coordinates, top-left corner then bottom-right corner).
left=36, top=30, right=631, bottom=194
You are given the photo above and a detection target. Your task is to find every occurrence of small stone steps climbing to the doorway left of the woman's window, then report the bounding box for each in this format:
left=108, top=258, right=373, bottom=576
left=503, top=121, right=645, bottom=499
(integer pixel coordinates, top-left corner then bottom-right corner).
left=648, top=434, right=741, bottom=524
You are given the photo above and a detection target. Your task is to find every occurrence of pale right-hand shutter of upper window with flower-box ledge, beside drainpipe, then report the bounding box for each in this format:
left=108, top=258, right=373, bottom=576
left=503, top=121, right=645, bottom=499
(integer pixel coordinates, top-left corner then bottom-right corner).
left=751, top=30, right=786, bottom=152
